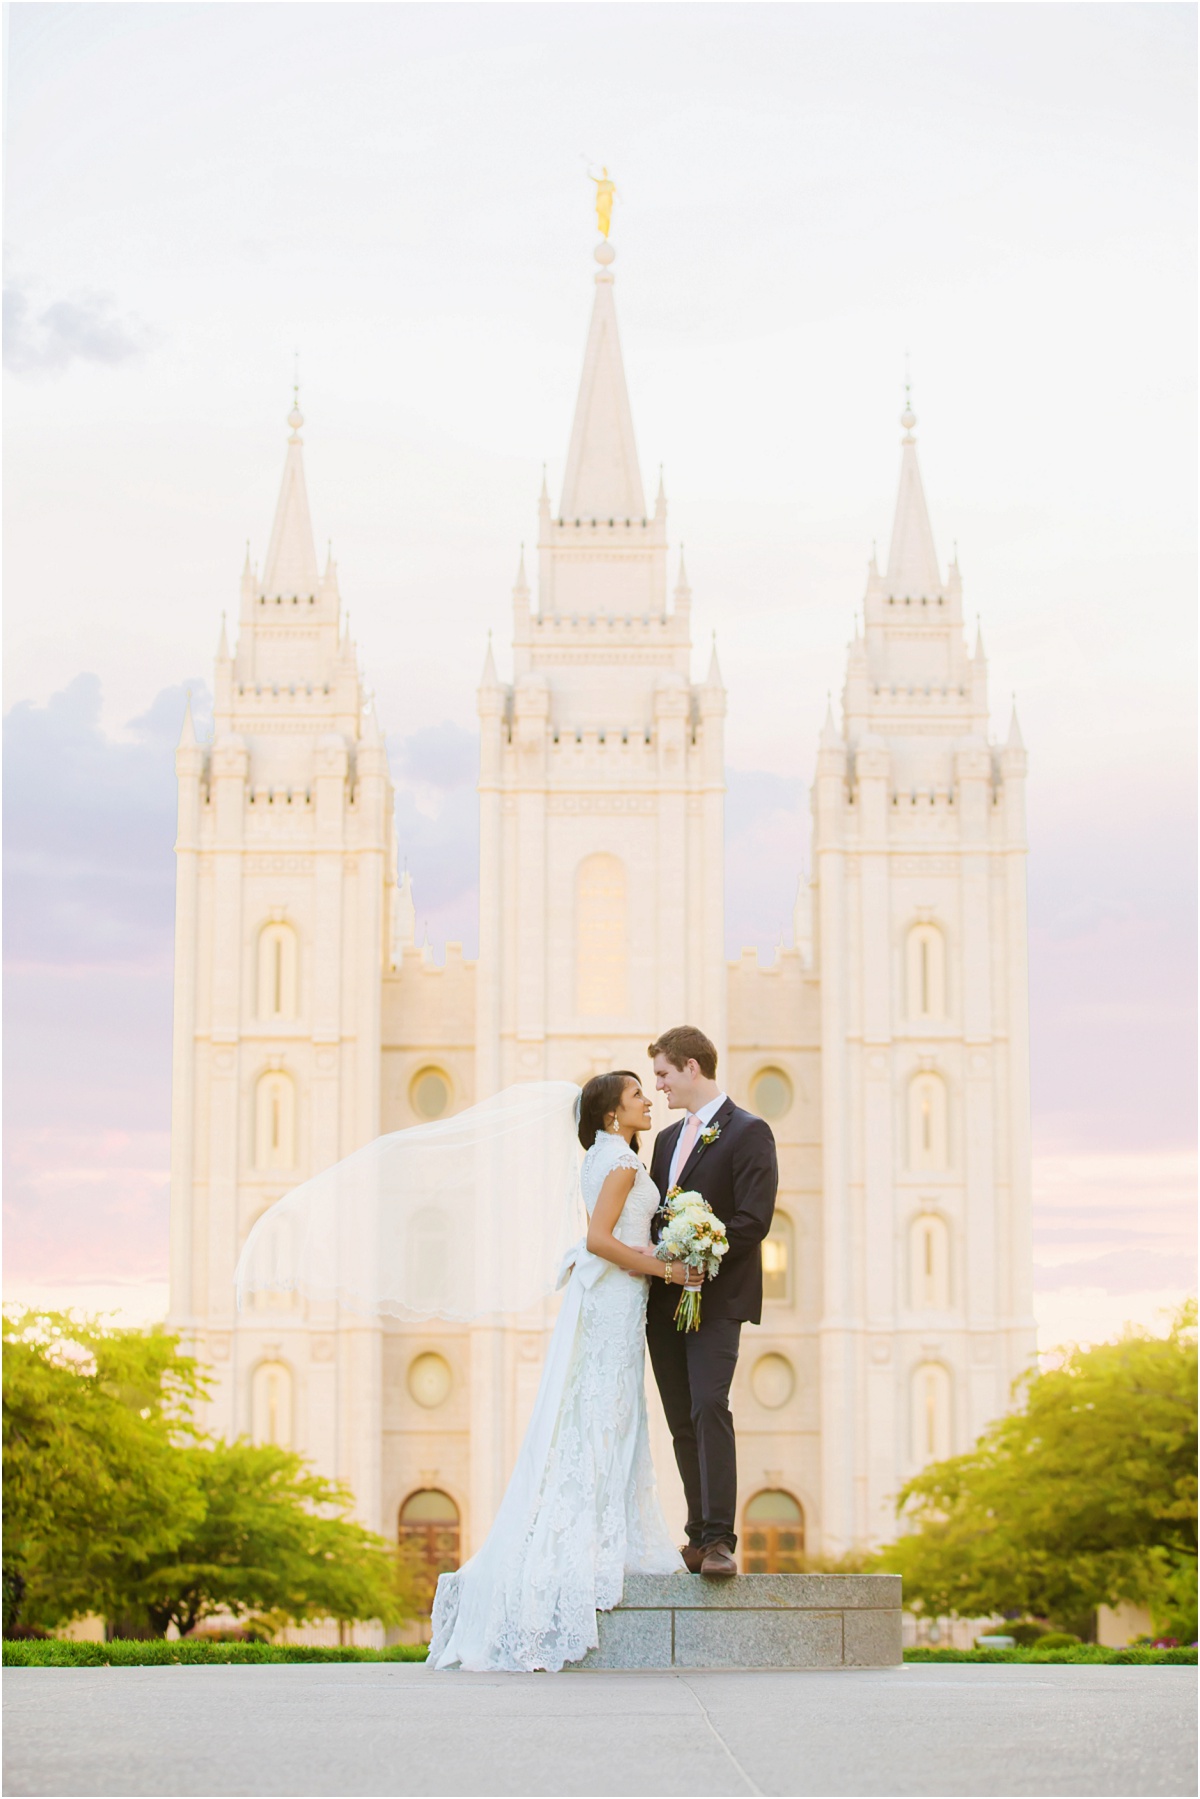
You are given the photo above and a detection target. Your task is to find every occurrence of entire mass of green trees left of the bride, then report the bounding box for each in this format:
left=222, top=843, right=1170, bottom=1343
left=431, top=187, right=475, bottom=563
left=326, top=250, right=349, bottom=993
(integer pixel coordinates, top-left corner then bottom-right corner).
left=4, top=1311, right=423, bottom=1637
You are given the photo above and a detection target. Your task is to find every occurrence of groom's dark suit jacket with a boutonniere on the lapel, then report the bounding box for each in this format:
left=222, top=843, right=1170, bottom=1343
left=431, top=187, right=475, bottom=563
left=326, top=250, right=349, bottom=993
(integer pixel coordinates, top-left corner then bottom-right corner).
left=649, top=1099, right=779, bottom=1329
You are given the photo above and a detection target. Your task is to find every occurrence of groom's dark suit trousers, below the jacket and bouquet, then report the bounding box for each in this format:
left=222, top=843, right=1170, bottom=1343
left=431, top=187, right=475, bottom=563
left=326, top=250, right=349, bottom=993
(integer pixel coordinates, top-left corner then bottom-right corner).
left=646, top=1302, right=741, bottom=1544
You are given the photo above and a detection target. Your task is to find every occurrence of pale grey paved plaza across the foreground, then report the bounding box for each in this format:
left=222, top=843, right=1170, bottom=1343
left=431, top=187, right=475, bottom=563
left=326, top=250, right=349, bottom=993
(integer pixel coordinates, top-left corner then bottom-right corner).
left=4, top=1662, right=1196, bottom=1799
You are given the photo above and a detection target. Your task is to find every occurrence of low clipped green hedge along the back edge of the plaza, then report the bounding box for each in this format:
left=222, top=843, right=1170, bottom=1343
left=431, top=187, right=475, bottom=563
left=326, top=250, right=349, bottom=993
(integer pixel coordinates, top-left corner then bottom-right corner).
left=4, top=1637, right=1196, bottom=1668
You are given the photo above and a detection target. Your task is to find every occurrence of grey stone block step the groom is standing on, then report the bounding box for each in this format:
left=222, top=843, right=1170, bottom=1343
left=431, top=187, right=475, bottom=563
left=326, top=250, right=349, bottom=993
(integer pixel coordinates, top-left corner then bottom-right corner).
left=570, top=1574, right=903, bottom=1669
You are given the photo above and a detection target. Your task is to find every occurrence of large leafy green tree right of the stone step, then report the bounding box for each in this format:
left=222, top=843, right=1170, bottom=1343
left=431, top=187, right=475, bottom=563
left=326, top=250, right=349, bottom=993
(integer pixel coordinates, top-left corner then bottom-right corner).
left=878, top=1301, right=1196, bottom=1641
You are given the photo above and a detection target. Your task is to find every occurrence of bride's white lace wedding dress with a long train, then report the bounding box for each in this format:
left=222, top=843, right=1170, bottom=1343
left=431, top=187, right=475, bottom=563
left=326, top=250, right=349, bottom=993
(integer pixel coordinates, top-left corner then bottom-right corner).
left=428, top=1133, right=684, bottom=1671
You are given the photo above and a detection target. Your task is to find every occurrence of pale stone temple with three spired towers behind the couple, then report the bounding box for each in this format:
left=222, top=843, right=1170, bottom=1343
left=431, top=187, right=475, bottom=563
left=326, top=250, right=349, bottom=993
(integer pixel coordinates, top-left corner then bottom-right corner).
left=171, top=245, right=1034, bottom=1572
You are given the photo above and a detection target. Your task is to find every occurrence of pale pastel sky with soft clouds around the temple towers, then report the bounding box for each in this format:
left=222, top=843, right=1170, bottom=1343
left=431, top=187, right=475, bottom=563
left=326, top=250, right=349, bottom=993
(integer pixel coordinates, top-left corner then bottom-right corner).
left=5, top=4, right=1196, bottom=1342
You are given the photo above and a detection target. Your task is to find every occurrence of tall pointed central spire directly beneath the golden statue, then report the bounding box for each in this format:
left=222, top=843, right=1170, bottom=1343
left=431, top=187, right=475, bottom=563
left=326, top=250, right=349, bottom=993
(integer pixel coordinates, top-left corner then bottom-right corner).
left=560, top=241, right=646, bottom=522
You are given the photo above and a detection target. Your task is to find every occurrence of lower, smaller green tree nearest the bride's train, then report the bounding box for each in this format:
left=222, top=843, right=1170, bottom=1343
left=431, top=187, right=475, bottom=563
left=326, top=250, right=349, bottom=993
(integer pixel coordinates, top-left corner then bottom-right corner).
left=126, top=1441, right=419, bottom=1635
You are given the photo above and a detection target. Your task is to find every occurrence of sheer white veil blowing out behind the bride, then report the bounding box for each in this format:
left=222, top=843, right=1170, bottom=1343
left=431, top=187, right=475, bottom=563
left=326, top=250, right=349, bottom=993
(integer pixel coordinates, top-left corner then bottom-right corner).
left=234, top=1081, right=583, bottom=1320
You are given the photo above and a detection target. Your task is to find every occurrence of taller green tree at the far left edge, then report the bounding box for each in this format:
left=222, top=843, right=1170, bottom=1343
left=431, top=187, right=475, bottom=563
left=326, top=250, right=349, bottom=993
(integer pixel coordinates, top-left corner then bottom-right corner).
left=4, top=1311, right=203, bottom=1633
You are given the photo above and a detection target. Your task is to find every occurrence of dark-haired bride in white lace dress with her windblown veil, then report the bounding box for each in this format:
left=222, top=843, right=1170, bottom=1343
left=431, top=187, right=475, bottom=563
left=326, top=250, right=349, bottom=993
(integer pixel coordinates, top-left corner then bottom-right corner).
left=236, top=1070, right=687, bottom=1671
